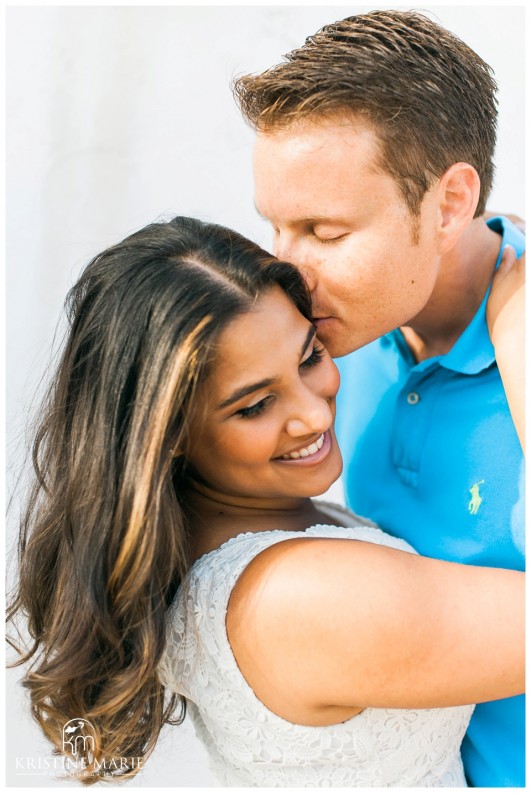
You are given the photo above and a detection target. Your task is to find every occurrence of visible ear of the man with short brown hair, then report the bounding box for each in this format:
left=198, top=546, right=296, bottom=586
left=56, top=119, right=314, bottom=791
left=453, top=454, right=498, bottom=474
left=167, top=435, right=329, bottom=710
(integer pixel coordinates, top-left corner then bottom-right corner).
left=438, top=162, right=481, bottom=253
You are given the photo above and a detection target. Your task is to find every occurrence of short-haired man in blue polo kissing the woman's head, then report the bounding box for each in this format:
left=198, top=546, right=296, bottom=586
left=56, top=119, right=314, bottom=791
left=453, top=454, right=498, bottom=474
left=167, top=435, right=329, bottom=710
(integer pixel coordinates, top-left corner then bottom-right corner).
left=235, top=11, right=525, bottom=787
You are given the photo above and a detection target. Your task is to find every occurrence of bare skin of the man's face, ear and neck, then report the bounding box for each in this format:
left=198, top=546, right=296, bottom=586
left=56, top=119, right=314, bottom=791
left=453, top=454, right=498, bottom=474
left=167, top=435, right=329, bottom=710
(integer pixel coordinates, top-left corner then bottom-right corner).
left=254, top=119, right=499, bottom=357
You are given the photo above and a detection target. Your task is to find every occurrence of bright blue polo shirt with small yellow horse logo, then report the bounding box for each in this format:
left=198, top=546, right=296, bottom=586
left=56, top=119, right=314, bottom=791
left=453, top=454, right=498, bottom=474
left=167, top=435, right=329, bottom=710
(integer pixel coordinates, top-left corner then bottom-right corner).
left=336, top=217, right=525, bottom=787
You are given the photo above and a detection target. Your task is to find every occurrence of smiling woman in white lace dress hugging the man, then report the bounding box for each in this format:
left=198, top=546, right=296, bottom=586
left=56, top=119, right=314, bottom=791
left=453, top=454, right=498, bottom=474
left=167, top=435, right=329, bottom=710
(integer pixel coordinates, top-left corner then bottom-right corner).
left=10, top=213, right=524, bottom=786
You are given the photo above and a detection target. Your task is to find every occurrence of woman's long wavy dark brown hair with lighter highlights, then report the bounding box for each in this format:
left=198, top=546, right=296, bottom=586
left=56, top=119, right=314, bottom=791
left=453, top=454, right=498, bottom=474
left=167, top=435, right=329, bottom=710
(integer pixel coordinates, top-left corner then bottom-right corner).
left=8, top=217, right=311, bottom=784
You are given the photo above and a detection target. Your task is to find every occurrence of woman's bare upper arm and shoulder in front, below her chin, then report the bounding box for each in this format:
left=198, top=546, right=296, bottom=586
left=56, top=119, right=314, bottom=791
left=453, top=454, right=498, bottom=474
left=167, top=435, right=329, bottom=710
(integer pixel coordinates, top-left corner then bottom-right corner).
left=227, top=538, right=525, bottom=724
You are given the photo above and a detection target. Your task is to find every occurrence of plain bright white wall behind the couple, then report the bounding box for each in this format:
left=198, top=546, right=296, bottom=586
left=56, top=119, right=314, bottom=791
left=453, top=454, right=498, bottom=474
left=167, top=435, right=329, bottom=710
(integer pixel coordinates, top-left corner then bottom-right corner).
left=6, top=5, right=525, bottom=789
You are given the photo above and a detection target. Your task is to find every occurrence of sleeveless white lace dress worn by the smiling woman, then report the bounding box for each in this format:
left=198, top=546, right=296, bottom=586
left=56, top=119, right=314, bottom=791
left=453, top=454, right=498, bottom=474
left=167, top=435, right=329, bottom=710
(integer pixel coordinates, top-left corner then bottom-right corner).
left=159, top=502, right=473, bottom=787
